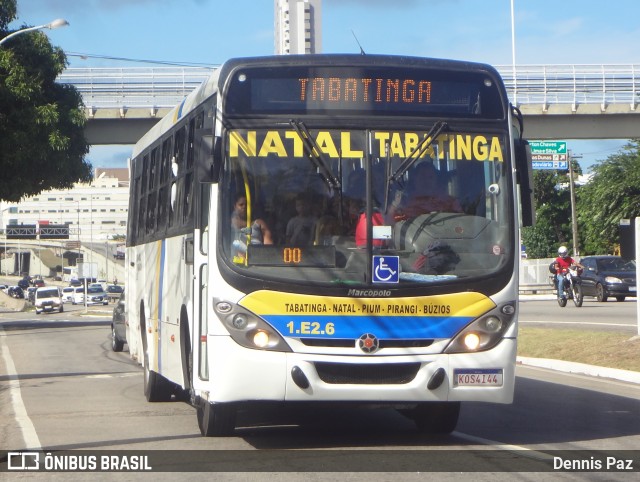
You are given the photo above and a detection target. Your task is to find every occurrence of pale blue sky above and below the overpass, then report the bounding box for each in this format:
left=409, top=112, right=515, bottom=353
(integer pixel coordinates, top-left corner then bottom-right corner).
left=10, top=0, right=640, bottom=172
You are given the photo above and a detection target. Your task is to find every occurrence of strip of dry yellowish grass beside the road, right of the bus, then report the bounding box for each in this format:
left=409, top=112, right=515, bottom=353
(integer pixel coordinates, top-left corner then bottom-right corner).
left=518, top=325, right=640, bottom=372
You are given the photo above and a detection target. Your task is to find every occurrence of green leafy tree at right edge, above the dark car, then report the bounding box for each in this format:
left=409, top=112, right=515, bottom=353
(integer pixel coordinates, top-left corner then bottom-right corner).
left=578, top=139, right=640, bottom=254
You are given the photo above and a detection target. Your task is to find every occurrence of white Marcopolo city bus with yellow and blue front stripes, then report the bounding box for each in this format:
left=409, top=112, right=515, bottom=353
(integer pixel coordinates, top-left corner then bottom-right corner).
left=126, top=55, right=533, bottom=436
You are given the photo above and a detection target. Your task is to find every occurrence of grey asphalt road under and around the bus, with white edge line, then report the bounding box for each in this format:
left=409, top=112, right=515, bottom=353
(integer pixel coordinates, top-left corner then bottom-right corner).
left=0, top=303, right=640, bottom=480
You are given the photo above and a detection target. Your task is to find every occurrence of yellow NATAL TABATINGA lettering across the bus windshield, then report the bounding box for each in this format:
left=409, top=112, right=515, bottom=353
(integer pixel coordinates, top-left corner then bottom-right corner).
left=229, top=130, right=504, bottom=162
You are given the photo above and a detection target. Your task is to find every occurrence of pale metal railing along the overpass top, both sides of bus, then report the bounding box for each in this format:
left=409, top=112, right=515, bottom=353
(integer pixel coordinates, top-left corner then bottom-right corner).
left=58, top=64, right=640, bottom=111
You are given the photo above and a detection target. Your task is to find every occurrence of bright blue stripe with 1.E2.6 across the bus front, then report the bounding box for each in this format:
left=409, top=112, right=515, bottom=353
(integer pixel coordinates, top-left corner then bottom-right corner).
left=263, top=314, right=474, bottom=340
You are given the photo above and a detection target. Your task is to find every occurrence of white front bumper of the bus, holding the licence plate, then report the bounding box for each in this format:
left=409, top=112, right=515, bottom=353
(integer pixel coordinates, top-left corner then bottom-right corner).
left=206, top=336, right=516, bottom=404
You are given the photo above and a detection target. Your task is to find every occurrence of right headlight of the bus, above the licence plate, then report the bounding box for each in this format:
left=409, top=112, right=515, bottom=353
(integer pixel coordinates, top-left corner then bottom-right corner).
left=444, top=302, right=516, bottom=353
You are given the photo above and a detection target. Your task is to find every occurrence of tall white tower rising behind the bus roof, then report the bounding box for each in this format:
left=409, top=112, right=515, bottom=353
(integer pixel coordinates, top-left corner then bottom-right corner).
left=274, top=0, right=322, bottom=55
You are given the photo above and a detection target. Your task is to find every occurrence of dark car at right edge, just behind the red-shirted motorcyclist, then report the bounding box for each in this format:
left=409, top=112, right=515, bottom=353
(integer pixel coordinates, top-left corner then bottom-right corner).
left=580, top=256, right=638, bottom=302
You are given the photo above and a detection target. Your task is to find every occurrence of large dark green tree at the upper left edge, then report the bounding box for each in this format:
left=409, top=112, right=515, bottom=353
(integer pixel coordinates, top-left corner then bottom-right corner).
left=0, top=0, right=91, bottom=202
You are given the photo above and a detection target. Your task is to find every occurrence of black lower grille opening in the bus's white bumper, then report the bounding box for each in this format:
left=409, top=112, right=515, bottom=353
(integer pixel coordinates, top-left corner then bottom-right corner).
left=315, top=362, right=420, bottom=385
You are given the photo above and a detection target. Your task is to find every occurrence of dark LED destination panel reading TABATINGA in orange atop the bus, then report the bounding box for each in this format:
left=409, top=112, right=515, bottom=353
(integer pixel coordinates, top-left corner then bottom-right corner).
left=225, top=66, right=505, bottom=119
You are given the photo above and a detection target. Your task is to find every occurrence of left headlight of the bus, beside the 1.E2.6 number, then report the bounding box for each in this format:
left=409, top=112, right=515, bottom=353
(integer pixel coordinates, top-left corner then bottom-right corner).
left=213, top=299, right=291, bottom=352
